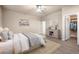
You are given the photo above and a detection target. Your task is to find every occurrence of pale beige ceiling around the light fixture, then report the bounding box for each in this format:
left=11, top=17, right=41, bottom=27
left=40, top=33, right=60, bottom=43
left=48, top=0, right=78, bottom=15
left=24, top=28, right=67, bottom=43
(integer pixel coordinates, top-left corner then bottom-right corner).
left=3, top=5, right=62, bottom=16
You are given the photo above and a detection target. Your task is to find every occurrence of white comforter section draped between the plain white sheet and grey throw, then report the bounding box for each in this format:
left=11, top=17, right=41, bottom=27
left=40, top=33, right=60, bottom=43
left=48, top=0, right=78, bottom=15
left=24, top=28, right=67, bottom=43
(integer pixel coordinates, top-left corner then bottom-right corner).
left=14, top=33, right=29, bottom=53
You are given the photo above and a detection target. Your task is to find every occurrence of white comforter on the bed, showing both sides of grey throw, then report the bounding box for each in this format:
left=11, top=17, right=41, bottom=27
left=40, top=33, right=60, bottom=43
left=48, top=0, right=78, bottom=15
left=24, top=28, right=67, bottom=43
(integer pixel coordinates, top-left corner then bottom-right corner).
left=0, top=33, right=45, bottom=54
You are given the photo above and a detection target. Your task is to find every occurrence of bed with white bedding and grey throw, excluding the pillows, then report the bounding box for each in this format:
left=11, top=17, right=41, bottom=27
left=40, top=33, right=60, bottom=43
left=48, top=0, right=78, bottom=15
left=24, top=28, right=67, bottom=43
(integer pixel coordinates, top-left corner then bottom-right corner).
left=0, top=27, right=45, bottom=54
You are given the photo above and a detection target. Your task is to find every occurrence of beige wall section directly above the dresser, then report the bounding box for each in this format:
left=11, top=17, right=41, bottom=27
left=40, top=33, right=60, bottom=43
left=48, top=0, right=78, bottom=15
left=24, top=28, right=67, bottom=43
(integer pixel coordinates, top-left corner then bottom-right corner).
left=46, top=10, right=62, bottom=30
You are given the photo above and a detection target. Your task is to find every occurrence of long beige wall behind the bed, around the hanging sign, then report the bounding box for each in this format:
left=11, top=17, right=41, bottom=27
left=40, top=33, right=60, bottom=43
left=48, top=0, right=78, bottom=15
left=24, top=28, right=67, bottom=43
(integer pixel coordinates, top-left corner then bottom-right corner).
left=3, top=9, right=41, bottom=33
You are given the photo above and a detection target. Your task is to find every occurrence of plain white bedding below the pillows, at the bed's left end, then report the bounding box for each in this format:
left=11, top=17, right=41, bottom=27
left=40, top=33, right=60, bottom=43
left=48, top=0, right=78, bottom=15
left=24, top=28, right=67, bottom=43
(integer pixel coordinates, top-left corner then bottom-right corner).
left=0, top=40, right=13, bottom=54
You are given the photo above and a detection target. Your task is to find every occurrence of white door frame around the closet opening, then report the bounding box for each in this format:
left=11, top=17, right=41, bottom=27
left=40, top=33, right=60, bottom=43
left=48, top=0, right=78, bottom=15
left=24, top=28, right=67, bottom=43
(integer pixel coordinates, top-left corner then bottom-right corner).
left=62, top=12, right=79, bottom=45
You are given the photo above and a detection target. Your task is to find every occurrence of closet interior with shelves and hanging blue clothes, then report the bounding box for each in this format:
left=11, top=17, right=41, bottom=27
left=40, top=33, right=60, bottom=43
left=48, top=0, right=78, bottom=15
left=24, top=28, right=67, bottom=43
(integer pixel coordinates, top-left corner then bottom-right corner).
left=70, top=15, right=77, bottom=39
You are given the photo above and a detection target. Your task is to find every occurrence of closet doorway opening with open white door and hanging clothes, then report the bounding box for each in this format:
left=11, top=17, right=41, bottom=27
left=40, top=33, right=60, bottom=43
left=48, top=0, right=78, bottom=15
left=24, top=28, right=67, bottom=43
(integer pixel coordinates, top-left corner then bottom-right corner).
left=65, top=14, right=78, bottom=42
